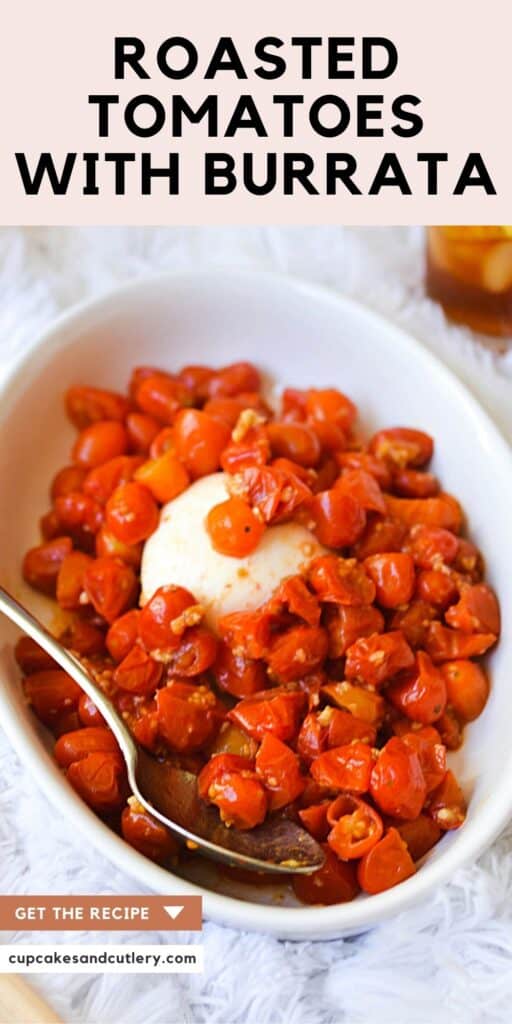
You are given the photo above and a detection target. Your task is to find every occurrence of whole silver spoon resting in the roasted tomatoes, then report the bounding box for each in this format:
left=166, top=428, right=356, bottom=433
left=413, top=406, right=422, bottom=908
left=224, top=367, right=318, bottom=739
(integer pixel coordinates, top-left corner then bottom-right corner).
left=0, top=587, right=325, bottom=874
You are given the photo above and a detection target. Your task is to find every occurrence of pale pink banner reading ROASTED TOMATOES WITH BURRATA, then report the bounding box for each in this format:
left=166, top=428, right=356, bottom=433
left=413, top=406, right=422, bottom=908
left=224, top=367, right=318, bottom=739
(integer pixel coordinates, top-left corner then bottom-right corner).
left=0, top=0, right=512, bottom=224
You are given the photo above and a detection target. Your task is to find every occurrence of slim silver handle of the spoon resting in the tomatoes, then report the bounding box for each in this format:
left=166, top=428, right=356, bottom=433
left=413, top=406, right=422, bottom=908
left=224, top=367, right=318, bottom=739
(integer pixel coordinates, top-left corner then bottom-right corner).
left=0, top=587, right=137, bottom=764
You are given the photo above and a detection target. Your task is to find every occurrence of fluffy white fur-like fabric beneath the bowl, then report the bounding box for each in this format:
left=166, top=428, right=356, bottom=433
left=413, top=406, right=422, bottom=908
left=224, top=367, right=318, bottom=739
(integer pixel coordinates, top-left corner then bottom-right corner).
left=0, top=227, right=512, bottom=1024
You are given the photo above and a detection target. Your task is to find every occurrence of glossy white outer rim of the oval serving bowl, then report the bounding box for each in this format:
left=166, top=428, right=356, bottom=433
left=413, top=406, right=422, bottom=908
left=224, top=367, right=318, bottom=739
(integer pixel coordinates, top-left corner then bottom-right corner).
left=0, top=265, right=512, bottom=939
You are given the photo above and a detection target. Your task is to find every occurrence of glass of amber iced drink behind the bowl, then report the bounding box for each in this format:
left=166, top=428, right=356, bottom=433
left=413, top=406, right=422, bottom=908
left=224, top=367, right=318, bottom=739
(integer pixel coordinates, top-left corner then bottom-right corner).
left=427, top=226, right=512, bottom=339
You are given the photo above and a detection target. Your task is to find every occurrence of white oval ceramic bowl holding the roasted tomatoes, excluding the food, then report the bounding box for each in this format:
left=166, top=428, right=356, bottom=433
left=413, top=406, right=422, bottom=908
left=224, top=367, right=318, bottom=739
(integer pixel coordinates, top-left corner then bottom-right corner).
left=0, top=271, right=512, bottom=939
